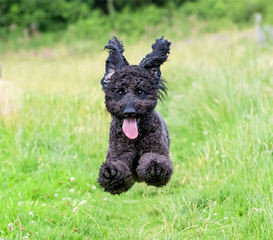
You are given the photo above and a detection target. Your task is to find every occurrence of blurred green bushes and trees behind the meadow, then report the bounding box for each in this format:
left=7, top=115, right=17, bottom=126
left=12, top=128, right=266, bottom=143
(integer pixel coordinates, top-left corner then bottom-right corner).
left=0, top=0, right=273, bottom=47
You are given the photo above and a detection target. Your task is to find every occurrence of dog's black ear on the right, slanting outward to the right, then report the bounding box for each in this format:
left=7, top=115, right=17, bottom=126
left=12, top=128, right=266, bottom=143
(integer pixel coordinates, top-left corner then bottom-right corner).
left=139, top=37, right=171, bottom=83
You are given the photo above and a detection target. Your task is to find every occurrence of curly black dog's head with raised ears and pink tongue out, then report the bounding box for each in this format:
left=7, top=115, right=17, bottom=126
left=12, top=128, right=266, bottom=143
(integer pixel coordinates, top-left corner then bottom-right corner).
left=101, top=37, right=171, bottom=139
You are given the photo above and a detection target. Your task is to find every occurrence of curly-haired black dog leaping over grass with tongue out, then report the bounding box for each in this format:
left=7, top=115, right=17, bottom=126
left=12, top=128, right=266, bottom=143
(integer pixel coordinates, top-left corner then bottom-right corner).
left=98, top=37, right=173, bottom=194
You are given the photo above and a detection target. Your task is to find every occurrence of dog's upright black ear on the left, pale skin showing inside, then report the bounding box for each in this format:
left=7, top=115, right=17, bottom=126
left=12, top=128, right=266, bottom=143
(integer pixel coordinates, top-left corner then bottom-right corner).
left=101, top=37, right=129, bottom=88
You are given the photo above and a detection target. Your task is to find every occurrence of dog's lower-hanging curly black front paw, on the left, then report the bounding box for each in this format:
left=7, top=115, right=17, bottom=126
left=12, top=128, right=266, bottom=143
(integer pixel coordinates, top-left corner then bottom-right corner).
left=98, top=161, right=134, bottom=194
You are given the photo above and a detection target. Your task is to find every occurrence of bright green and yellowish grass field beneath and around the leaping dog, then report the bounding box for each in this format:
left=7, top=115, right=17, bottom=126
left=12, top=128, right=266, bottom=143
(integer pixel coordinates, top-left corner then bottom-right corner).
left=0, top=31, right=273, bottom=240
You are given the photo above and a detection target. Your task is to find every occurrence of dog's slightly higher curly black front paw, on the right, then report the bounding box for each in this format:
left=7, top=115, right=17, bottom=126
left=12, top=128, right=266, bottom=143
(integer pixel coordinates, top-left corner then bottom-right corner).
left=136, top=153, right=173, bottom=187
